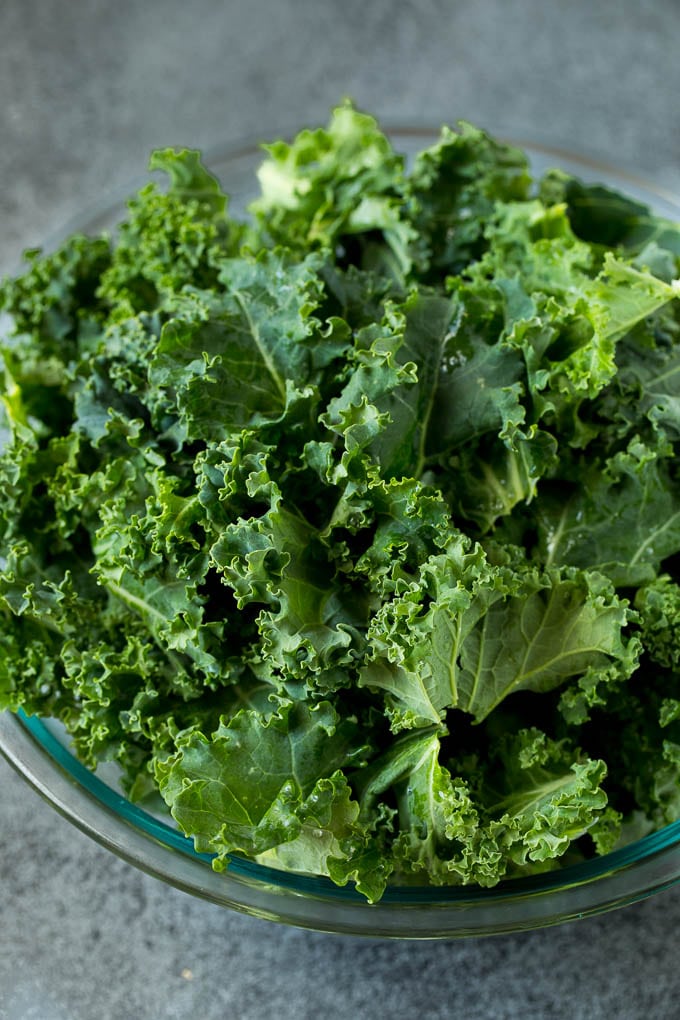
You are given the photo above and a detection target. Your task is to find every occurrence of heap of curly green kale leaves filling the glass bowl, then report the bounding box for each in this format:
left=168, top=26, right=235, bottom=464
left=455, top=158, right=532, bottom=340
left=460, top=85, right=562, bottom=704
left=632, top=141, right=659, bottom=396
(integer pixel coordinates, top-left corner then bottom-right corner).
left=0, top=103, right=680, bottom=902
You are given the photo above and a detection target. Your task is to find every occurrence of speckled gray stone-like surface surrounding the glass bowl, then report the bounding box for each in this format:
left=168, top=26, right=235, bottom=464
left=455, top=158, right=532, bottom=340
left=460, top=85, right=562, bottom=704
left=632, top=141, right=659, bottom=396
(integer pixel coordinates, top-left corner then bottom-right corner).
left=0, top=0, right=680, bottom=1020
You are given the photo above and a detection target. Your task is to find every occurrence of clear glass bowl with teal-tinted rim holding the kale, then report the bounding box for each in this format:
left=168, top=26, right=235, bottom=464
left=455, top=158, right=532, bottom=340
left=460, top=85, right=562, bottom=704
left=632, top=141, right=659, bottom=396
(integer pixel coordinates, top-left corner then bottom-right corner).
left=0, top=135, right=680, bottom=938
